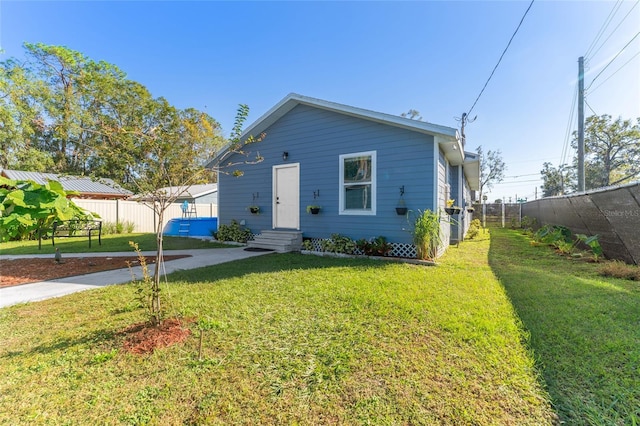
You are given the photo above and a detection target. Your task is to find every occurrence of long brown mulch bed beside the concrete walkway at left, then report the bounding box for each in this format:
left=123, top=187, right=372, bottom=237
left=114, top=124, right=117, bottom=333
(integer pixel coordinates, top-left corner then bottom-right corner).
left=0, top=255, right=190, bottom=288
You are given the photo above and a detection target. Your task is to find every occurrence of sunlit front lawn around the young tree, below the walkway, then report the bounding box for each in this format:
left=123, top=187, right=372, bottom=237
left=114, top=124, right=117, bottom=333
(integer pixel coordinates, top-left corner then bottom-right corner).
left=0, top=231, right=554, bottom=425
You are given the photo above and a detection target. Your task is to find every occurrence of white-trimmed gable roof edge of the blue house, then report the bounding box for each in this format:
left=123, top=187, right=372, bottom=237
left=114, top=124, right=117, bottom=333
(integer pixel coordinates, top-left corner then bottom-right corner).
left=242, top=93, right=464, bottom=165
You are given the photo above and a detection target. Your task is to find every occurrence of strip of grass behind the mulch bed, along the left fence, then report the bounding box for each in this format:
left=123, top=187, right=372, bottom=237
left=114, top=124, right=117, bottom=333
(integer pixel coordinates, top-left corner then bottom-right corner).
left=0, top=234, right=229, bottom=254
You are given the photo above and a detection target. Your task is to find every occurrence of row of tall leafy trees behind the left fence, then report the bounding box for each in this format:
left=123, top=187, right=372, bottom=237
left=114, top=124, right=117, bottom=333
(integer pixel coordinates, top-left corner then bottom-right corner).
left=0, top=43, right=227, bottom=192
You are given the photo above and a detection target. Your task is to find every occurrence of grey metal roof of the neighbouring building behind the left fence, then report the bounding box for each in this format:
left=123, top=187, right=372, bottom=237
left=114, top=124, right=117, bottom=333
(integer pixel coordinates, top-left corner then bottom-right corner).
left=0, top=169, right=133, bottom=200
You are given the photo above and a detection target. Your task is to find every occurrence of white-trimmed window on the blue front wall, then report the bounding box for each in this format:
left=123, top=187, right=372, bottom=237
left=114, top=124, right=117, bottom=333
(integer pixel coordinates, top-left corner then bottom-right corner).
left=340, top=151, right=376, bottom=215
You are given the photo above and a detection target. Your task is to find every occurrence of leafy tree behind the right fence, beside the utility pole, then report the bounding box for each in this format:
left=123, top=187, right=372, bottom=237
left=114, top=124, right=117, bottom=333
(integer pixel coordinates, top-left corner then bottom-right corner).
left=573, top=114, right=640, bottom=189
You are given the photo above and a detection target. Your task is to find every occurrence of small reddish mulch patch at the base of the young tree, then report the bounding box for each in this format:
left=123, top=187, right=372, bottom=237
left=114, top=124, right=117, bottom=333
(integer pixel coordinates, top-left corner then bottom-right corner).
left=123, top=318, right=193, bottom=355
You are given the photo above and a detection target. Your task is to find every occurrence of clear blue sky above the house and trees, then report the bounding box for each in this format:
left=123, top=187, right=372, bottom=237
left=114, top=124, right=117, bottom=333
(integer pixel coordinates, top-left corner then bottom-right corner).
left=0, top=0, right=640, bottom=201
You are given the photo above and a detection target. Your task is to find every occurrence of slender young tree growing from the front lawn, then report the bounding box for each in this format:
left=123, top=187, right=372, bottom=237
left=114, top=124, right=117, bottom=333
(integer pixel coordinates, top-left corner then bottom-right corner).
left=100, top=104, right=262, bottom=325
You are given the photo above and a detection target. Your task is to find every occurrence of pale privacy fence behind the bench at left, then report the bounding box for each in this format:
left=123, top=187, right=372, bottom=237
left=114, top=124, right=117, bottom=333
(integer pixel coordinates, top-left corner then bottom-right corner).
left=73, top=198, right=218, bottom=232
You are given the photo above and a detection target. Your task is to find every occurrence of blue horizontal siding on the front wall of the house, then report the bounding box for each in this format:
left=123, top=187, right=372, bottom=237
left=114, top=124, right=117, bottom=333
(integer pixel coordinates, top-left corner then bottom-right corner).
left=219, top=105, right=436, bottom=243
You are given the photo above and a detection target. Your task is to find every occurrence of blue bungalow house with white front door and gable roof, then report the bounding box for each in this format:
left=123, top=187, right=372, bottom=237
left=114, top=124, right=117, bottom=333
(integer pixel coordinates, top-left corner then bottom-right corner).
left=211, top=94, right=479, bottom=257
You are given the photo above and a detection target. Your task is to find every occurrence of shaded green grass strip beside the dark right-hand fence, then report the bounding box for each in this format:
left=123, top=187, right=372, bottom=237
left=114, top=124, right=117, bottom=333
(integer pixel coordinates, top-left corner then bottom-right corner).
left=489, top=229, right=640, bottom=425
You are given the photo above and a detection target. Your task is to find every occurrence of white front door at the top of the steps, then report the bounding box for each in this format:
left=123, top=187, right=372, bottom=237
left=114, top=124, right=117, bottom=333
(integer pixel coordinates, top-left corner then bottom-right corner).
left=273, top=163, right=300, bottom=229
